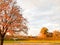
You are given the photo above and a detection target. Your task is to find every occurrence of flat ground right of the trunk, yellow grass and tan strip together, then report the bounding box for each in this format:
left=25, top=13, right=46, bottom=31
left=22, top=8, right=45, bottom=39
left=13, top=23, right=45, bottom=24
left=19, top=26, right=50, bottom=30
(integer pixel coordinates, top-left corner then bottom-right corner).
left=4, top=40, right=60, bottom=45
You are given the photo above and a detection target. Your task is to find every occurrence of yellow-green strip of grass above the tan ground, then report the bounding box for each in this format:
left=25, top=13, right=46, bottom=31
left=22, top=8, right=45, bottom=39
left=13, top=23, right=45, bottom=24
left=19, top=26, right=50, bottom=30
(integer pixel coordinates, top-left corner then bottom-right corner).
left=4, top=40, right=60, bottom=43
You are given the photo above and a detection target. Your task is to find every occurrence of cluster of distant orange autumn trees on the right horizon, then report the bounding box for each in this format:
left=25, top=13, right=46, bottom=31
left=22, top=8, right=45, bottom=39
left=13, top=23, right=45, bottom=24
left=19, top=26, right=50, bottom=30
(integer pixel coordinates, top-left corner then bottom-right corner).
left=38, top=27, right=60, bottom=40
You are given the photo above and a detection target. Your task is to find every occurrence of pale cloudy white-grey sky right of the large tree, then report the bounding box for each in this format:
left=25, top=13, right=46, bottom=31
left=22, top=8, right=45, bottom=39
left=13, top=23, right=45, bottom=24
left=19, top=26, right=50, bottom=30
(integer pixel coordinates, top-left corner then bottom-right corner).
left=17, top=0, right=60, bottom=36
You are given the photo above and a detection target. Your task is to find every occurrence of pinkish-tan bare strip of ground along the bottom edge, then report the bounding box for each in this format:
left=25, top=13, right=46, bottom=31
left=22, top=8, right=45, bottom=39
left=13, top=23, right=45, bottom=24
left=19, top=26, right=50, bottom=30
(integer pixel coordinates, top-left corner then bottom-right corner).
left=4, top=42, right=60, bottom=45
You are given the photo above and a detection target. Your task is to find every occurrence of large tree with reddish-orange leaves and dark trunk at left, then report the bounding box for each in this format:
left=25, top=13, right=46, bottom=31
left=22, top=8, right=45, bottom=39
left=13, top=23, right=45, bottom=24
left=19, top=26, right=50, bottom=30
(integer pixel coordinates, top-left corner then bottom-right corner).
left=0, top=0, right=28, bottom=45
